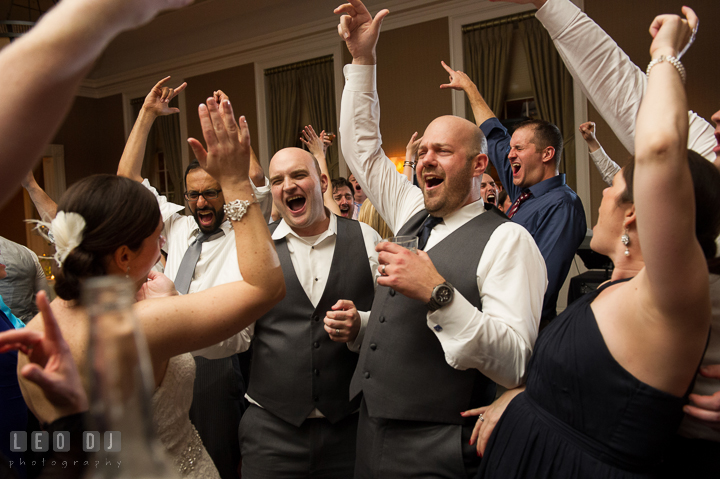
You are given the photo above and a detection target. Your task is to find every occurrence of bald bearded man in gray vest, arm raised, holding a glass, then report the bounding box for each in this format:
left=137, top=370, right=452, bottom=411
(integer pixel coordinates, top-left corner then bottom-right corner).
left=335, top=0, right=547, bottom=479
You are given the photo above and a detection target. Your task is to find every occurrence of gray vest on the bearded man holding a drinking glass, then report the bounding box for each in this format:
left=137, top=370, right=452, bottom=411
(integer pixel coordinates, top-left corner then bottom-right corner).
left=350, top=210, right=509, bottom=424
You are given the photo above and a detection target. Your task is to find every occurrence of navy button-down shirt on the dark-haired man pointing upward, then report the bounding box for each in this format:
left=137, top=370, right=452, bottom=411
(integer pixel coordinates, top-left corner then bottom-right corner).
left=480, top=118, right=587, bottom=320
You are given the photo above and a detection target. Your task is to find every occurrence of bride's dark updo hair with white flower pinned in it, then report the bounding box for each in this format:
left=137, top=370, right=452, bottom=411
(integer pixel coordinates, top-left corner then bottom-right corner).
left=55, top=175, right=160, bottom=301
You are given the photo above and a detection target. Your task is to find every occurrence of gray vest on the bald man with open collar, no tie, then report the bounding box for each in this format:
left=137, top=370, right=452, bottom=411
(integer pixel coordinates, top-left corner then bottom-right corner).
left=248, top=218, right=375, bottom=426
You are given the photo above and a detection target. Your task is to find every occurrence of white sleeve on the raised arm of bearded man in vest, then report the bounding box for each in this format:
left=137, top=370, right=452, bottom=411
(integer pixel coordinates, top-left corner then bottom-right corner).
left=339, top=65, right=424, bottom=232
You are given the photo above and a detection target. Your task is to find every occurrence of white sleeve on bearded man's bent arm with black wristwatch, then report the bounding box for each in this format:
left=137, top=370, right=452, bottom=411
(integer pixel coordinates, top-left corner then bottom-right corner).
left=427, top=223, right=547, bottom=389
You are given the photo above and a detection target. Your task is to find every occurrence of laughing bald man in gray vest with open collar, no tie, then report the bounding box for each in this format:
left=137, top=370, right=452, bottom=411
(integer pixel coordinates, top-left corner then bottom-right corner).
left=229, top=148, right=380, bottom=479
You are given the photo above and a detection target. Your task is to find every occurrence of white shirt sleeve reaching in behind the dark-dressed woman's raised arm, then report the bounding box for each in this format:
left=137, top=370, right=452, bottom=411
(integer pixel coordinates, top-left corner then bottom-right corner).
left=535, top=0, right=717, bottom=161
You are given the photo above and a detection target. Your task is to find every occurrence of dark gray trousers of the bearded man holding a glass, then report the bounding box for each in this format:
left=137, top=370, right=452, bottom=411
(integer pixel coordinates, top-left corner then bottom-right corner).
left=355, top=399, right=480, bottom=479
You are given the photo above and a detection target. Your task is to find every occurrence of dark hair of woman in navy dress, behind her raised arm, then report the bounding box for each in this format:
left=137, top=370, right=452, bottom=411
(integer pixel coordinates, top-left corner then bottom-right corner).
left=620, top=150, right=720, bottom=274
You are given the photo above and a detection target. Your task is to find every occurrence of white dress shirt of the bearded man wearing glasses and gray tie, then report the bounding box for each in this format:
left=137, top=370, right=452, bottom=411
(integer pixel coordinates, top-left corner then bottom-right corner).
left=143, top=178, right=272, bottom=359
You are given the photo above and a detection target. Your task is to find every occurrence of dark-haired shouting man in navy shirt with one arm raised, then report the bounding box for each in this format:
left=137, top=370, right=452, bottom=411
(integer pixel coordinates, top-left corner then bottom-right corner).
left=441, top=63, right=587, bottom=324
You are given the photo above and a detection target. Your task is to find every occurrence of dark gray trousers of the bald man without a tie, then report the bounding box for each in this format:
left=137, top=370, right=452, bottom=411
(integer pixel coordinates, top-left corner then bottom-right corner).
left=238, top=404, right=358, bottom=479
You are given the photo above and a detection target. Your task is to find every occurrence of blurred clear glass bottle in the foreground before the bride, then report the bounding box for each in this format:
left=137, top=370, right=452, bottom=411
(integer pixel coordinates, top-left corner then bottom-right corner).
left=82, top=276, right=179, bottom=479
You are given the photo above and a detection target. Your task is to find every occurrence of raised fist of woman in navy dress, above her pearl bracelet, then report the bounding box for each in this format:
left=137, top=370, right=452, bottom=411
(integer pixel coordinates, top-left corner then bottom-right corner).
left=650, top=7, right=700, bottom=58
